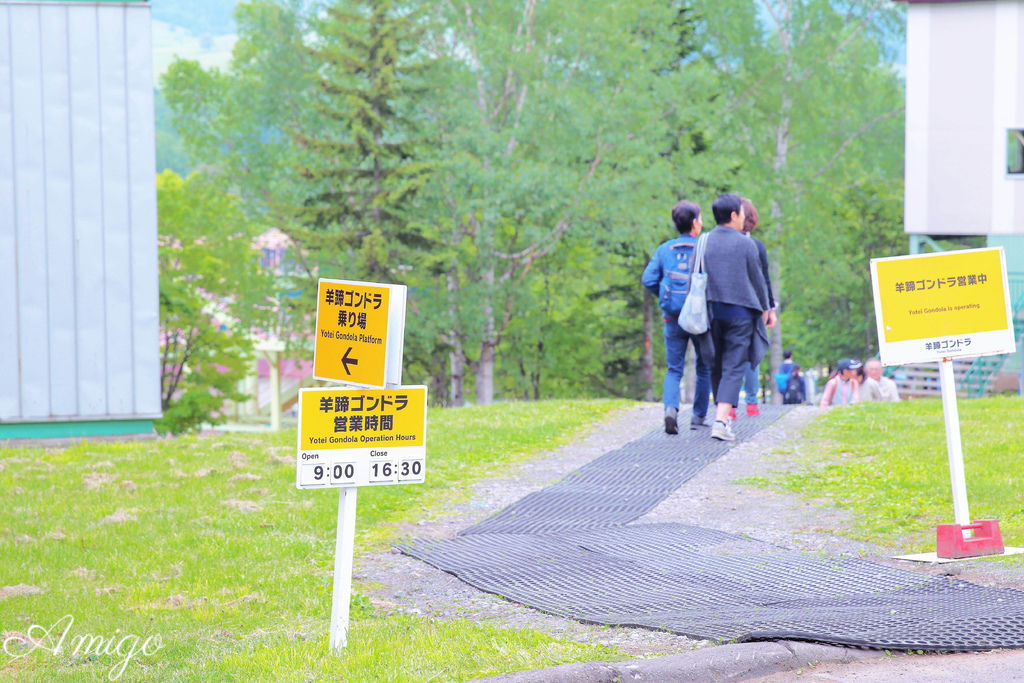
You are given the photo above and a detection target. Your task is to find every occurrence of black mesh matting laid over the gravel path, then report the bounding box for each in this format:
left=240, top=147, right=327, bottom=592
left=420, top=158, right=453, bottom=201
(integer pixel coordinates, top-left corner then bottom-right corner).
left=400, top=407, right=1024, bottom=651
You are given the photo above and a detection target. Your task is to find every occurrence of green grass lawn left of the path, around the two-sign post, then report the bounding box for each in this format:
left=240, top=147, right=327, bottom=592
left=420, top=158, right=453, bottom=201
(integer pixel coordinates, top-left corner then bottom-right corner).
left=0, top=400, right=631, bottom=681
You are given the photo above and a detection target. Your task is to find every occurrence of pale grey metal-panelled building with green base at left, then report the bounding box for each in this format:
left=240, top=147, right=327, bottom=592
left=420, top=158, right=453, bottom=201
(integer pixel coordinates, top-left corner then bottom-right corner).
left=0, top=0, right=161, bottom=441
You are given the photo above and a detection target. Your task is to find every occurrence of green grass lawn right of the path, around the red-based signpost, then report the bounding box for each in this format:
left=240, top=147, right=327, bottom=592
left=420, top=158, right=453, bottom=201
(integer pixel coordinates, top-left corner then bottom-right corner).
left=752, top=396, right=1024, bottom=564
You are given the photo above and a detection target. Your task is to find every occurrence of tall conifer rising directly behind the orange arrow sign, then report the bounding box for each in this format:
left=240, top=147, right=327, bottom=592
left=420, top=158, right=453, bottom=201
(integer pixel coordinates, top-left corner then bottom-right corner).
left=293, top=0, right=430, bottom=282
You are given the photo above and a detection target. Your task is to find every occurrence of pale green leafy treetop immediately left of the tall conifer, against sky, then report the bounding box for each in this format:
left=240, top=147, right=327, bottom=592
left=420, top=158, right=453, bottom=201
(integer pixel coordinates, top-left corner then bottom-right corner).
left=161, top=0, right=314, bottom=220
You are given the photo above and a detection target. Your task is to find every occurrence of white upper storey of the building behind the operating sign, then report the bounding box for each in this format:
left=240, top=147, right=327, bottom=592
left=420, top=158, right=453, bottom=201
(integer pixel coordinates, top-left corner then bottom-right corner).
left=904, top=0, right=1024, bottom=250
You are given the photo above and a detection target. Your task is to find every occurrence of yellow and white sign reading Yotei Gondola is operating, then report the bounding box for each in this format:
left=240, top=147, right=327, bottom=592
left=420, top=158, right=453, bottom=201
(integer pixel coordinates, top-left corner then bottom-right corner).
left=871, top=248, right=1014, bottom=365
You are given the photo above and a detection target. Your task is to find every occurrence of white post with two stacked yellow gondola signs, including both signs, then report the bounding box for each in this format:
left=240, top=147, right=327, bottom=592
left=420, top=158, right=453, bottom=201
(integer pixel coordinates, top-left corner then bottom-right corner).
left=295, top=279, right=427, bottom=654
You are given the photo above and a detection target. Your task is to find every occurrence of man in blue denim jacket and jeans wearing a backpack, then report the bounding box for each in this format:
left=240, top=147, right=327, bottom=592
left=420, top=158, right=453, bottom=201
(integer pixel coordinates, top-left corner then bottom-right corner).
left=640, top=200, right=711, bottom=434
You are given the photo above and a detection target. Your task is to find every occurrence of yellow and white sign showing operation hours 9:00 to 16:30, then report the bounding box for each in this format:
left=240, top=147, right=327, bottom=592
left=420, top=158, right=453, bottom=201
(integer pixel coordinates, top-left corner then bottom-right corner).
left=296, top=386, right=427, bottom=488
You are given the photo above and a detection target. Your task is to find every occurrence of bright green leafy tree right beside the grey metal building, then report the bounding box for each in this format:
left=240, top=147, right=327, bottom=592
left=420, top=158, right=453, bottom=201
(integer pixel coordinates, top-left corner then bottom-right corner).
left=157, top=171, right=273, bottom=433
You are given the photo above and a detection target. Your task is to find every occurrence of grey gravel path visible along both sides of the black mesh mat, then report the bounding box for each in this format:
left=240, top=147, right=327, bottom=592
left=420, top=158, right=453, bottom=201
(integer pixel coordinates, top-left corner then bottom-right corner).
left=353, top=403, right=1024, bottom=657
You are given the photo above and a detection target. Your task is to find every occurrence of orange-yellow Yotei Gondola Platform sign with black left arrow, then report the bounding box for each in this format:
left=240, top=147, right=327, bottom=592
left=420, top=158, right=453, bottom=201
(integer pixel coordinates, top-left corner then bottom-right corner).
left=313, top=280, right=406, bottom=387
